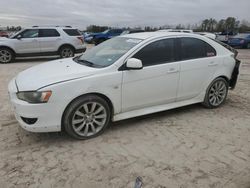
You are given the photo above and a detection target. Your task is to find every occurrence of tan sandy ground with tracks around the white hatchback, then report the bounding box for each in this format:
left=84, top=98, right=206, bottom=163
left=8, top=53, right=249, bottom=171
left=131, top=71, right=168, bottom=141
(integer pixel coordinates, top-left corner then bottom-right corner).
left=0, top=50, right=250, bottom=188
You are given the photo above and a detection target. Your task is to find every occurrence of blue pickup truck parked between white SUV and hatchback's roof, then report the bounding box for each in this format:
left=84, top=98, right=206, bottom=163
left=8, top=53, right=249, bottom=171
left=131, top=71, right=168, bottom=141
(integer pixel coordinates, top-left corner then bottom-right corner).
left=85, top=29, right=123, bottom=45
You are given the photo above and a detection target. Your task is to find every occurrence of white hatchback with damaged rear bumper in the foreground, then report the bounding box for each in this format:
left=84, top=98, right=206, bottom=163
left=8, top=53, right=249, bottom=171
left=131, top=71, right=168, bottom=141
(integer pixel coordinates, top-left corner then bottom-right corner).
left=9, top=32, right=240, bottom=139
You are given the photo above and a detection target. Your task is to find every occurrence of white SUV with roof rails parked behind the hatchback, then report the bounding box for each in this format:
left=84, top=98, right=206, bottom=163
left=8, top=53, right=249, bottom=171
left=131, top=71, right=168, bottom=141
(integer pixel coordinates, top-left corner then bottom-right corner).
left=0, top=26, right=86, bottom=63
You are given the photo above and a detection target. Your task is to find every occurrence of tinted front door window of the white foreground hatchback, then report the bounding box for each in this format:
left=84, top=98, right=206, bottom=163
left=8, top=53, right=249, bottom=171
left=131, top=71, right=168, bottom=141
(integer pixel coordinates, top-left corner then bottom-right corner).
left=133, top=39, right=175, bottom=66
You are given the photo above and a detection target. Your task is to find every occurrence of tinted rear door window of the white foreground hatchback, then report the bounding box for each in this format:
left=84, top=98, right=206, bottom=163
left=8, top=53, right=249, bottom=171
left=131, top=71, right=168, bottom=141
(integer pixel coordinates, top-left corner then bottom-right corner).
left=181, top=37, right=216, bottom=60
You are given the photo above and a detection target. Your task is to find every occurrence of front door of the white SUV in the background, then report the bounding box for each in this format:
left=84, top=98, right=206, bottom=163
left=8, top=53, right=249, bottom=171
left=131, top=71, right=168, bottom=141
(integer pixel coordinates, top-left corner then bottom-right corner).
left=13, top=29, right=40, bottom=54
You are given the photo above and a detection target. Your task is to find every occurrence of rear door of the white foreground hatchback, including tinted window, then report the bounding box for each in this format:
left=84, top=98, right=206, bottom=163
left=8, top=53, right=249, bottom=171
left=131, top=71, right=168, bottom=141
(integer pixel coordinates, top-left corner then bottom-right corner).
left=177, top=37, right=220, bottom=101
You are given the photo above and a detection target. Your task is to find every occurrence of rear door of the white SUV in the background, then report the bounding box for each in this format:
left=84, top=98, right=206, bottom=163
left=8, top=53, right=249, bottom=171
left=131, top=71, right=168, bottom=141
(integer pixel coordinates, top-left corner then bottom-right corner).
left=38, top=29, right=62, bottom=52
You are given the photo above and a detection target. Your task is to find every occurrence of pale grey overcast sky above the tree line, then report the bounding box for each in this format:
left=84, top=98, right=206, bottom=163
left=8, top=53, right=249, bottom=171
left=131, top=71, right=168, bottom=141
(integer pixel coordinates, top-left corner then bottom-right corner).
left=0, top=0, right=250, bottom=29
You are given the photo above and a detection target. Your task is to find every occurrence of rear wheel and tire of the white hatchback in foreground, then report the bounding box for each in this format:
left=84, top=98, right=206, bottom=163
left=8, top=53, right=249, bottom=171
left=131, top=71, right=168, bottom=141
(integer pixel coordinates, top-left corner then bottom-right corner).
left=202, top=77, right=228, bottom=108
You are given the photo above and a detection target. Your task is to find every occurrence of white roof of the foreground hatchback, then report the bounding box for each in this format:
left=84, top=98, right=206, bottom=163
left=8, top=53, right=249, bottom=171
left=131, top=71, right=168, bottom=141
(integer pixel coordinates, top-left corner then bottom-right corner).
left=120, top=32, right=204, bottom=40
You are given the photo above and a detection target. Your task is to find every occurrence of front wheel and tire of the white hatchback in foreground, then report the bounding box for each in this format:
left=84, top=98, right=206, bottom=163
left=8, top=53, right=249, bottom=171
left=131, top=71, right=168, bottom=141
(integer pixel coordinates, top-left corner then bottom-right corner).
left=62, top=95, right=111, bottom=140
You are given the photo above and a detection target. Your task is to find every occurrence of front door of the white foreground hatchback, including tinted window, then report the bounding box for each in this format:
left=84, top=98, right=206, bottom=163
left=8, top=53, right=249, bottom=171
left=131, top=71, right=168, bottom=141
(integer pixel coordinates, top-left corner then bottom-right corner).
left=122, top=39, right=180, bottom=112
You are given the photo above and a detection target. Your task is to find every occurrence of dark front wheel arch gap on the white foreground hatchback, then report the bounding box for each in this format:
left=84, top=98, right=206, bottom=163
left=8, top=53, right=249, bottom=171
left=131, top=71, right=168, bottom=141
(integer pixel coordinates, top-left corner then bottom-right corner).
left=61, top=92, right=114, bottom=130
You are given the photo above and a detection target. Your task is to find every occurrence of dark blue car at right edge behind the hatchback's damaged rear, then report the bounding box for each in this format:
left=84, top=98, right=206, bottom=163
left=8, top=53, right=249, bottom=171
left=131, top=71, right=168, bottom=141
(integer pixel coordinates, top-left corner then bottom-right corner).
left=228, top=33, right=250, bottom=49
